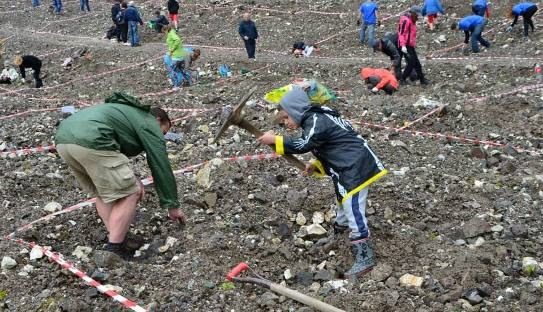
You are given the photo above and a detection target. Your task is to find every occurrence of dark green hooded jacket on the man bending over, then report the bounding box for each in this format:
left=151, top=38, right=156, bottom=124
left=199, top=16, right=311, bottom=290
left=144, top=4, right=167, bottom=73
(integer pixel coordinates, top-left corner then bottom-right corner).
left=55, top=92, right=179, bottom=209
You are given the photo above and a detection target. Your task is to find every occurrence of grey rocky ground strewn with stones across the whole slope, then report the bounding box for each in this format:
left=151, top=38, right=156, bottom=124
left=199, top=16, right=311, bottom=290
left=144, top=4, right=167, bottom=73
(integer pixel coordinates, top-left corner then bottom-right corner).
left=0, top=0, right=543, bottom=312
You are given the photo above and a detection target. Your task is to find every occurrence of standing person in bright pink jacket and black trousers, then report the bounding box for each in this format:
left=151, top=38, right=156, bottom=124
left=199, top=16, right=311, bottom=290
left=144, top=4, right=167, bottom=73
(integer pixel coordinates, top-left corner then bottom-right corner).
left=398, top=5, right=430, bottom=85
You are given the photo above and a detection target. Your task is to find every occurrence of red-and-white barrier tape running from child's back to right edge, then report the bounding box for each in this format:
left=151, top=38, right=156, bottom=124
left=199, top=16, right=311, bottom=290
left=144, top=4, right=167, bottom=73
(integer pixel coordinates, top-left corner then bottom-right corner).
left=351, top=121, right=543, bottom=156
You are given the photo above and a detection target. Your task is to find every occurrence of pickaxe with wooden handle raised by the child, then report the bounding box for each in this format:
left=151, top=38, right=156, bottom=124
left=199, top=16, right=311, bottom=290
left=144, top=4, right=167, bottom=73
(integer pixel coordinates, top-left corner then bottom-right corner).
left=215, top=87, right=305, bottom=171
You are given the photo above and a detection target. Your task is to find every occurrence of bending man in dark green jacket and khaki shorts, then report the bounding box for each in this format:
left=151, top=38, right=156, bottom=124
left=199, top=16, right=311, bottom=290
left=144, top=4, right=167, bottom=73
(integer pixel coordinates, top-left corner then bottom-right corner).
left=55, top=93, right=186, bottom=259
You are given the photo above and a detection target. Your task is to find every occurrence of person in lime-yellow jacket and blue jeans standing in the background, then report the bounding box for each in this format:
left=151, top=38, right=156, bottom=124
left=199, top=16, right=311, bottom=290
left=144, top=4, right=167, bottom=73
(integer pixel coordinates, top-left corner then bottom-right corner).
left=162, top=25, right=185, bottom=90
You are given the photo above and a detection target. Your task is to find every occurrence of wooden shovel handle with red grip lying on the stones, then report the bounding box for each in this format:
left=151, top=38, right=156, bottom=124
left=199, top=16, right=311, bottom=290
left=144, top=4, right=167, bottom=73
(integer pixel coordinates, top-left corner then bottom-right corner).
left=226, top=262, right=345, bottom=312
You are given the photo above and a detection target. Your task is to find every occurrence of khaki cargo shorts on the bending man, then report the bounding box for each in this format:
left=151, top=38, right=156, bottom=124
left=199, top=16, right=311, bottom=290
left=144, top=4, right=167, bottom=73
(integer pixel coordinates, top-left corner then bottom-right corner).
left=56, top=144, right=140, bottom=203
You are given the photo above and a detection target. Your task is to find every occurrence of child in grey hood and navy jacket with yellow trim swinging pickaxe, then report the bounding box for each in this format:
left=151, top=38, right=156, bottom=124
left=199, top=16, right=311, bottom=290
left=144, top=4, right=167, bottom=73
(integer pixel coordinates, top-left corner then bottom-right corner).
left=258, top=87, right=387, bottom=276
